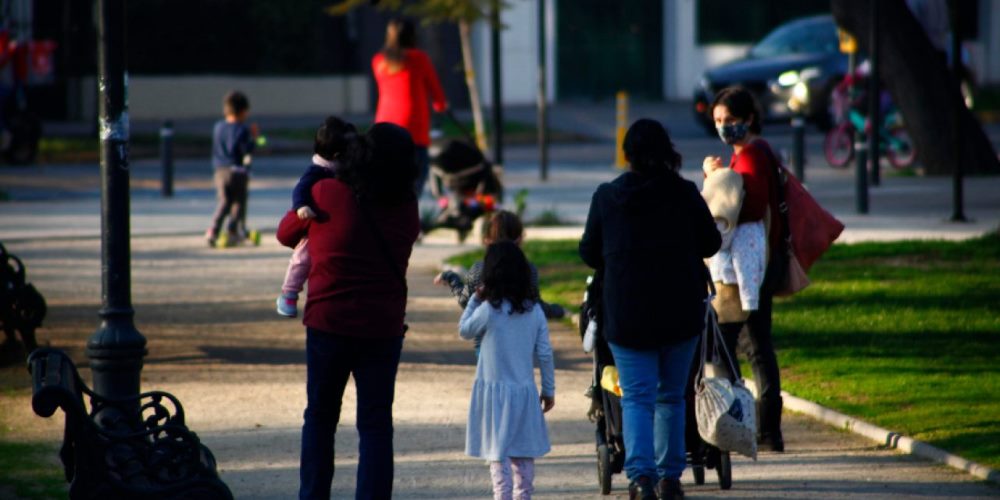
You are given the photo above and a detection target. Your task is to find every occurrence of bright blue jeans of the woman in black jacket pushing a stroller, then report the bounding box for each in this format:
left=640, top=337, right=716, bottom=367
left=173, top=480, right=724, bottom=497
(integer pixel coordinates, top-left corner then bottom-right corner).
left=608, top=335, right=698, bottom=483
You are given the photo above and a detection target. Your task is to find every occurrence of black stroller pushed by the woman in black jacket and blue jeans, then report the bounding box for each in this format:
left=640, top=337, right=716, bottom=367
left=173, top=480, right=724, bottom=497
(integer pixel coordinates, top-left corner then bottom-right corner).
left=579, top=271, right=733, bottom=495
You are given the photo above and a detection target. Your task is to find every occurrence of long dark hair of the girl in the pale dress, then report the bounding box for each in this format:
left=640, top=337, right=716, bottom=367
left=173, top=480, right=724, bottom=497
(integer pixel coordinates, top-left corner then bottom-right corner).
left=483, top=241, right=538, bottom=314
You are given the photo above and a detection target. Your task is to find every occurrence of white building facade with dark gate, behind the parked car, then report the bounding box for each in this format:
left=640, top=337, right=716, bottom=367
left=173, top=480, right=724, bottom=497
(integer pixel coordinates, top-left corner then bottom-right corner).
left=474, top=0, right=1000, bottom=105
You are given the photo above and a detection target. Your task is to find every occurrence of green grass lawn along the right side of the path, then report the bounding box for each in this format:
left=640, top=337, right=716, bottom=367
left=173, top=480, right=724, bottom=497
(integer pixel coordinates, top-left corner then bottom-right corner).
left=454, top=233, right=1000, bottom=468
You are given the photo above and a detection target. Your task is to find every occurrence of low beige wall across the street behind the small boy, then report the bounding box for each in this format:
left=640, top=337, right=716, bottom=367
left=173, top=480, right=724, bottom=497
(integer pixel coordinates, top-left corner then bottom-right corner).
left=114, top=75, right=369, bottom=120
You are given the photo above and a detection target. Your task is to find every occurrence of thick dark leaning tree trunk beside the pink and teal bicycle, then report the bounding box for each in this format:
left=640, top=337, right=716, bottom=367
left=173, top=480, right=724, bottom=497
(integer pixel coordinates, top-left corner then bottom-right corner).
left=831, top=0, right=1000, bottom=175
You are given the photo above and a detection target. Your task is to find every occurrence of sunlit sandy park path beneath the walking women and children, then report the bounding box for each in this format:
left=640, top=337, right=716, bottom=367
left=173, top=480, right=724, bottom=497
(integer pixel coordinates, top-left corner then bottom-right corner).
left=0, top=236, right=1000, bottom=499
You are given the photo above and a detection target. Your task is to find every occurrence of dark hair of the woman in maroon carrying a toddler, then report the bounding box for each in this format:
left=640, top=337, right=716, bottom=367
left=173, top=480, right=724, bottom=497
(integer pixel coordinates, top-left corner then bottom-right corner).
left=337, top=123, right=417, bottom=204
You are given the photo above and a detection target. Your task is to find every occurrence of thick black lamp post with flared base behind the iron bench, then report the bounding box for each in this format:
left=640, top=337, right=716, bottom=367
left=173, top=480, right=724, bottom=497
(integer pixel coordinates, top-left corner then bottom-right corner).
left=87, top=0, right=146, bottom=410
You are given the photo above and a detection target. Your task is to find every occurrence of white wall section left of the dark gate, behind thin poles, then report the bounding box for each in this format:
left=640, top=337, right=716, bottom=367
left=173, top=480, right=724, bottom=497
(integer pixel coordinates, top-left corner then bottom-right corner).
left=472, top=0, right=557, bottom=106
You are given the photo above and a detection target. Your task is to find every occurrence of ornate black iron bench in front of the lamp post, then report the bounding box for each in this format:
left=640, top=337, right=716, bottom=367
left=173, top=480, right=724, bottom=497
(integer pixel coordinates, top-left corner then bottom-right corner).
left=28, top=348, right=233, bottom=500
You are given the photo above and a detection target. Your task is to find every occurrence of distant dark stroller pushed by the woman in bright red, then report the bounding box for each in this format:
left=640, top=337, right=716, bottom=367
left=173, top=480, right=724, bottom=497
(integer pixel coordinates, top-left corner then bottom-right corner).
left=422, top=110, right=503, bottom=243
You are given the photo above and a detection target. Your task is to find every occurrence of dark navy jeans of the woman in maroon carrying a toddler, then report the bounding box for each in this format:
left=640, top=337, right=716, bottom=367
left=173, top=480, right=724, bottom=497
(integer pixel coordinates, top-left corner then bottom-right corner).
left=299, top=328, right=403, bottom=500
